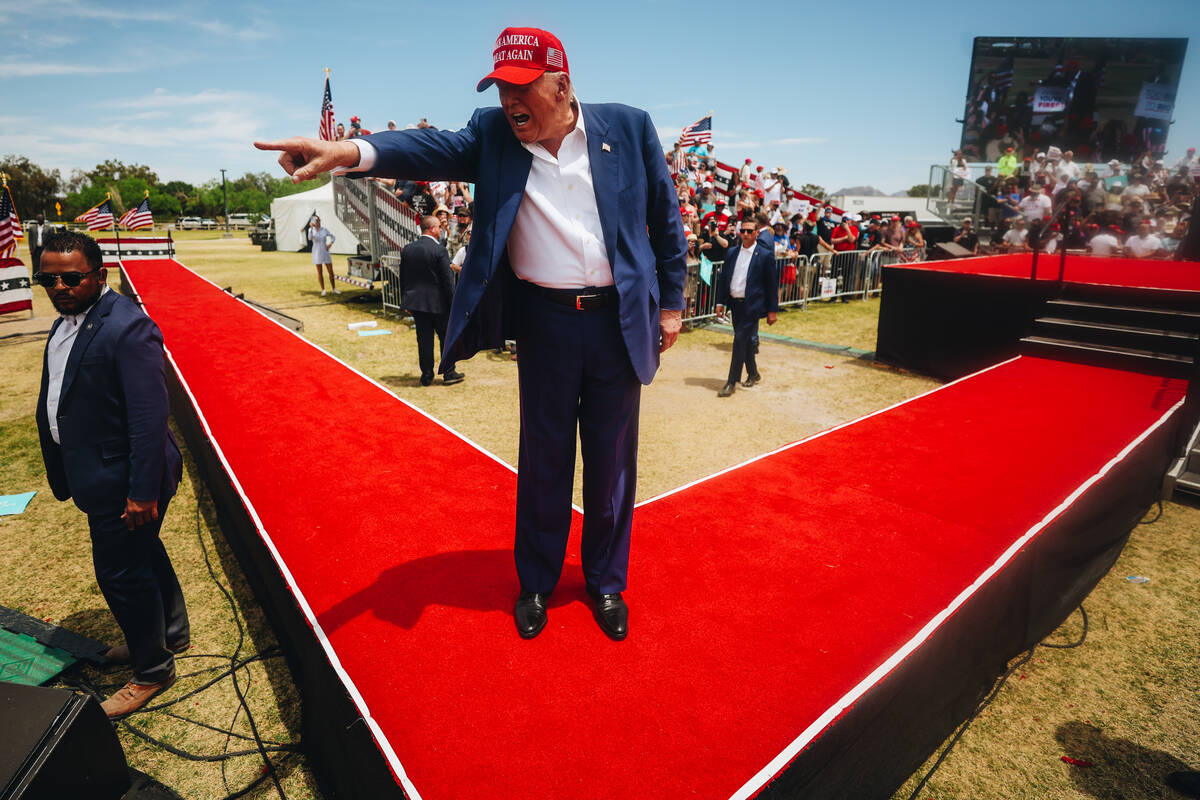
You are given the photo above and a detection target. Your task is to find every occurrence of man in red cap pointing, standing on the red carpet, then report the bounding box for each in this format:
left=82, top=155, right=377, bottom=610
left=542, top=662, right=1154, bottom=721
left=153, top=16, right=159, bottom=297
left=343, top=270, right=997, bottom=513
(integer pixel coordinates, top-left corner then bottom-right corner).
left=256, top=28, right=688, bottom=640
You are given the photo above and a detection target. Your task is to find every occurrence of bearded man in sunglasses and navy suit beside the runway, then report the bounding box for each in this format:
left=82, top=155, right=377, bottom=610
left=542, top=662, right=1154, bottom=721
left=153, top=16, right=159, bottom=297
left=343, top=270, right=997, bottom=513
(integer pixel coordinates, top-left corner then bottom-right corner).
left=34, top=231, right=191, bottom=718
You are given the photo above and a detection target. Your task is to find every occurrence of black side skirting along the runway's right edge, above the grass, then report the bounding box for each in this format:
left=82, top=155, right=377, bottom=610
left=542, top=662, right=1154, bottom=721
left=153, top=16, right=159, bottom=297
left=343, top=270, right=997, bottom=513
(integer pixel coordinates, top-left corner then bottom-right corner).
left=758, top=395, right=1183, bottom=800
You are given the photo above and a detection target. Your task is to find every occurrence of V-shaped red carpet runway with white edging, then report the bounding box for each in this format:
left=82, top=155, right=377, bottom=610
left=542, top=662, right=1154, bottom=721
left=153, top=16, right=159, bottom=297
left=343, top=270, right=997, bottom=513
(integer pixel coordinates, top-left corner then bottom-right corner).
left=124, top=260, right=1186, bottom=800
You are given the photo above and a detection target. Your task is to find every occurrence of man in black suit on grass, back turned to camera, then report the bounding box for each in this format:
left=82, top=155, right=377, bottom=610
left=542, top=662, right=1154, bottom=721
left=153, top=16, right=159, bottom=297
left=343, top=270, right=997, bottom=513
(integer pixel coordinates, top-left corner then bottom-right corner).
left=400, top=215, right=466, bottom=386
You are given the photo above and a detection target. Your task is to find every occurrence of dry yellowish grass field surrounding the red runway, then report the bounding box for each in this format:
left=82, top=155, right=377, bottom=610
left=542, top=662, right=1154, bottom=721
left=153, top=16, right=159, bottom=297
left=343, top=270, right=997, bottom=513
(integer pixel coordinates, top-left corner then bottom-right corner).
left=0, top=231, right=1200, bottom=800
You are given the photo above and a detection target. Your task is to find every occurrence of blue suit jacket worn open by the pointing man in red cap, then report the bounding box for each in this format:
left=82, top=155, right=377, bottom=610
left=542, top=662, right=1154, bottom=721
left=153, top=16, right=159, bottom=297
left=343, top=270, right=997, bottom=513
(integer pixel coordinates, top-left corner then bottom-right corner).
left=355, top=103, right=688, bottom=384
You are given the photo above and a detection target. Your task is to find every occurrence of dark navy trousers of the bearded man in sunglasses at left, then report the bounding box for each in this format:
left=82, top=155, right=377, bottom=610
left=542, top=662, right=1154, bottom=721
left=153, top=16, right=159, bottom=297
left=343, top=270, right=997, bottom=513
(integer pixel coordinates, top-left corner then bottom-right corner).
left=88, top=498, right=191, bottom=684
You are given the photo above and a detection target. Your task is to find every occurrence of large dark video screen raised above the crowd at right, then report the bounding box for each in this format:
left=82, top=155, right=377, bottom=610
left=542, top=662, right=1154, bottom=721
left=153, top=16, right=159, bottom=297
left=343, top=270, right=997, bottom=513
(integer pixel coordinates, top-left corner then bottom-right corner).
left=960, top=36, right=1188, bottom=163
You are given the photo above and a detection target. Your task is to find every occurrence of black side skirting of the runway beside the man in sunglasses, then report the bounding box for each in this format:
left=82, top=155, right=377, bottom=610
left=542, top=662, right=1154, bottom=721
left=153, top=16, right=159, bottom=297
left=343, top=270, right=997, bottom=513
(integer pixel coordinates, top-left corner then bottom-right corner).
left=121, top=271, right=406, bottom=800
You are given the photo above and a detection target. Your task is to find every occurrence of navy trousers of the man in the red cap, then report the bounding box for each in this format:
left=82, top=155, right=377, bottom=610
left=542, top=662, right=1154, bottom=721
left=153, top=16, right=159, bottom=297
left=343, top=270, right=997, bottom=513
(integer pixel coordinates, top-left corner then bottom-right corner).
left=515, top=282, right=642, bottom=594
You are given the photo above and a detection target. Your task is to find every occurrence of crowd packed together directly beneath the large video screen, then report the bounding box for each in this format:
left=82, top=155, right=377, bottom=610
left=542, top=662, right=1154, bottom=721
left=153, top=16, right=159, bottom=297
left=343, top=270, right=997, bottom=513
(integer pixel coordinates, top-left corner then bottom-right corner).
left=964, top=146, right=1200, bottom=258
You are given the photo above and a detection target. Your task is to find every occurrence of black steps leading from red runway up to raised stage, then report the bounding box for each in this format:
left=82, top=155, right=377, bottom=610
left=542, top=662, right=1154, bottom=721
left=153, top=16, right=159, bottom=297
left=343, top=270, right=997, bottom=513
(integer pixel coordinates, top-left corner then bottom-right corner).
left=1020, top=287, right=1200, bottom=378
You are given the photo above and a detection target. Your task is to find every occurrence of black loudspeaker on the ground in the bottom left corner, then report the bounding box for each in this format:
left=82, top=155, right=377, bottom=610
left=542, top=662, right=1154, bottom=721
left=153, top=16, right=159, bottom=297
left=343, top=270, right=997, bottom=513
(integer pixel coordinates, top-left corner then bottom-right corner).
left=0, top=682, right=130, bottom=800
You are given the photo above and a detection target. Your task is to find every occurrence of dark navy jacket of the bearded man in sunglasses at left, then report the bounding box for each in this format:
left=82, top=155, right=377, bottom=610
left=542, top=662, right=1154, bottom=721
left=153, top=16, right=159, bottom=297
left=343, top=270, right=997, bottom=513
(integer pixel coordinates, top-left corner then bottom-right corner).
left=36, top=291, right=182, bottom=513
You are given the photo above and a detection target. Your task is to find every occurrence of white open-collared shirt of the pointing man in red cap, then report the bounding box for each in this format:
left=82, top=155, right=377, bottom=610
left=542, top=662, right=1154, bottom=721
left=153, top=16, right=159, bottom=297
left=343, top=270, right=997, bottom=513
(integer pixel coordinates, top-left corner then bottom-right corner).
left=343, top=109, right=613, bottom=289
